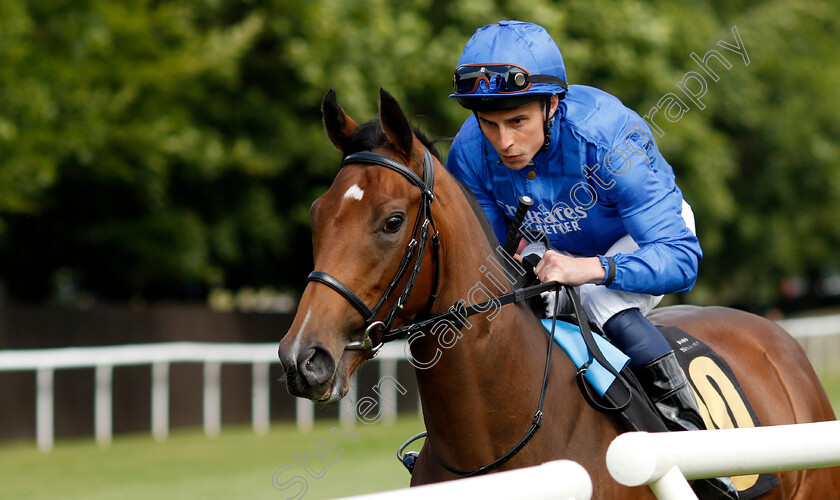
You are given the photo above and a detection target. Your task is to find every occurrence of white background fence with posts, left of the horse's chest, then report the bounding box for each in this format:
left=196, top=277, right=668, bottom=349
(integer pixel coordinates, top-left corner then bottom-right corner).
left=0, top=342, right=405, bottom=451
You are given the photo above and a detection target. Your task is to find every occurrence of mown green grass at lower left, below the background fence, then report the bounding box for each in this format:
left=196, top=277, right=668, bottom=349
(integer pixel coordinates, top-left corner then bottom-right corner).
left=0, top=417, right=423, bottom=500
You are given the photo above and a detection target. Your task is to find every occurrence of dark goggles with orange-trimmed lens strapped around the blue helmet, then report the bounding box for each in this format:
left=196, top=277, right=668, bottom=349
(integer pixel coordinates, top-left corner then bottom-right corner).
left=452, top=64, right=569, bottom=95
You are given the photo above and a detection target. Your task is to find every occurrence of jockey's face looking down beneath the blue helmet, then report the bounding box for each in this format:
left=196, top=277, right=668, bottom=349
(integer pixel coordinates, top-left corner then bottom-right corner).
left=478, top=96, right=559, bottom=170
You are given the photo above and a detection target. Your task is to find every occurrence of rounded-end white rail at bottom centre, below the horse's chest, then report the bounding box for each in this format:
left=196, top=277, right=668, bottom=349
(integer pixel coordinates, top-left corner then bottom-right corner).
left=334, top=460, right=592, bottom=500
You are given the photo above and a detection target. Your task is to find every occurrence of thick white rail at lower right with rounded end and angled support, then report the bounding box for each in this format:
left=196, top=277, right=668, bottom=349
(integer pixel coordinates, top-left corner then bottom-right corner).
left=607, top=421, right=840, bottom=500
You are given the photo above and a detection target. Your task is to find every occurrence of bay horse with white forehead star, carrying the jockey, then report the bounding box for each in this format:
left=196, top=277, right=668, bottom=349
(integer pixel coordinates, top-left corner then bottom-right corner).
left=279, top=90, right=840, bottom=500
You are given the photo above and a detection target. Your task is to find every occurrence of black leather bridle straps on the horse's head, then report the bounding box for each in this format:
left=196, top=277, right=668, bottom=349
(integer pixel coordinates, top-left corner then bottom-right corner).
left=306, top=148, right=440, bottom=355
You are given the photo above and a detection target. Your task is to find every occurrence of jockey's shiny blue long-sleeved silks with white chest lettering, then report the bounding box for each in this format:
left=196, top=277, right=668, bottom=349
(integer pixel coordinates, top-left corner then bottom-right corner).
left=446, top=81, right=703, bottom=295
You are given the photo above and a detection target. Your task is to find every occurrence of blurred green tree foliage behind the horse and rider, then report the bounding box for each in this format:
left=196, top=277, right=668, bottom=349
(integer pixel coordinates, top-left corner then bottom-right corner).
left=0, top=0, right=840, bottom=310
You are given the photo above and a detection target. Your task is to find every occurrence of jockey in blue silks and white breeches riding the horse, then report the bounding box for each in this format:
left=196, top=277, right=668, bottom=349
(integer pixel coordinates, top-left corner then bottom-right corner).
left=446, top=21, right=737, bottom=499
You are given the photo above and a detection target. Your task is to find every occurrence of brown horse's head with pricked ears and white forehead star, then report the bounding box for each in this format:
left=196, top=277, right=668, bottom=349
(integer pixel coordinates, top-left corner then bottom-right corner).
left=279, top=90, right=436, bottom=402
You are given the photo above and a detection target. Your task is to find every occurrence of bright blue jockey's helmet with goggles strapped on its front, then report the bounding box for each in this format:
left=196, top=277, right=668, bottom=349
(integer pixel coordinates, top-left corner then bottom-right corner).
left=449, top=21, right=569, bottom=111
